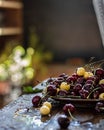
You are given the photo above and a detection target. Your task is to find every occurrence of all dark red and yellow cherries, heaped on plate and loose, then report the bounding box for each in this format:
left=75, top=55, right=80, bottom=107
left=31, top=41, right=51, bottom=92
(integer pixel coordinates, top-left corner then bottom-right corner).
left=32, top=67, right=104, bottom=128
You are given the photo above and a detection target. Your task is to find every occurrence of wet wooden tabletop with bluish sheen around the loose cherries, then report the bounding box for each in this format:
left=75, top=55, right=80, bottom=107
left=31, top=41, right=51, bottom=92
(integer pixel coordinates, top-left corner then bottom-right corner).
left=0, top=82, right=104, bottom=130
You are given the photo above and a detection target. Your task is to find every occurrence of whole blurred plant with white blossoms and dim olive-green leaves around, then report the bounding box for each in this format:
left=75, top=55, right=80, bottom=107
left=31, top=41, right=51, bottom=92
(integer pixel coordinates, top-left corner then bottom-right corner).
left=0, top=27, right=53, bottom=85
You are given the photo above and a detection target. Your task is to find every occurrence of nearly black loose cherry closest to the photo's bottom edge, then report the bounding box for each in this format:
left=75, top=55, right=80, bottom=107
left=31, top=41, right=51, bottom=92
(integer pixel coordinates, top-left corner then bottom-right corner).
left=57, top=115, right=70, bottom=129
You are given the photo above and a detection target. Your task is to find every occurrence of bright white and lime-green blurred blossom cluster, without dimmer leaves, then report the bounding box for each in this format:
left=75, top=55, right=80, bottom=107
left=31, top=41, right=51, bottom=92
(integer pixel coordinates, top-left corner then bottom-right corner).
left=0, top=45, right=35, bottom=86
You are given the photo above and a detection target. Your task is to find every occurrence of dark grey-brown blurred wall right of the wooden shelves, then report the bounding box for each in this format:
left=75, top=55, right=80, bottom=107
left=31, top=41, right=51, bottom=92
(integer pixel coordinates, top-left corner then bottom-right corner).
left=23, top=0, right=104, bottom=62
